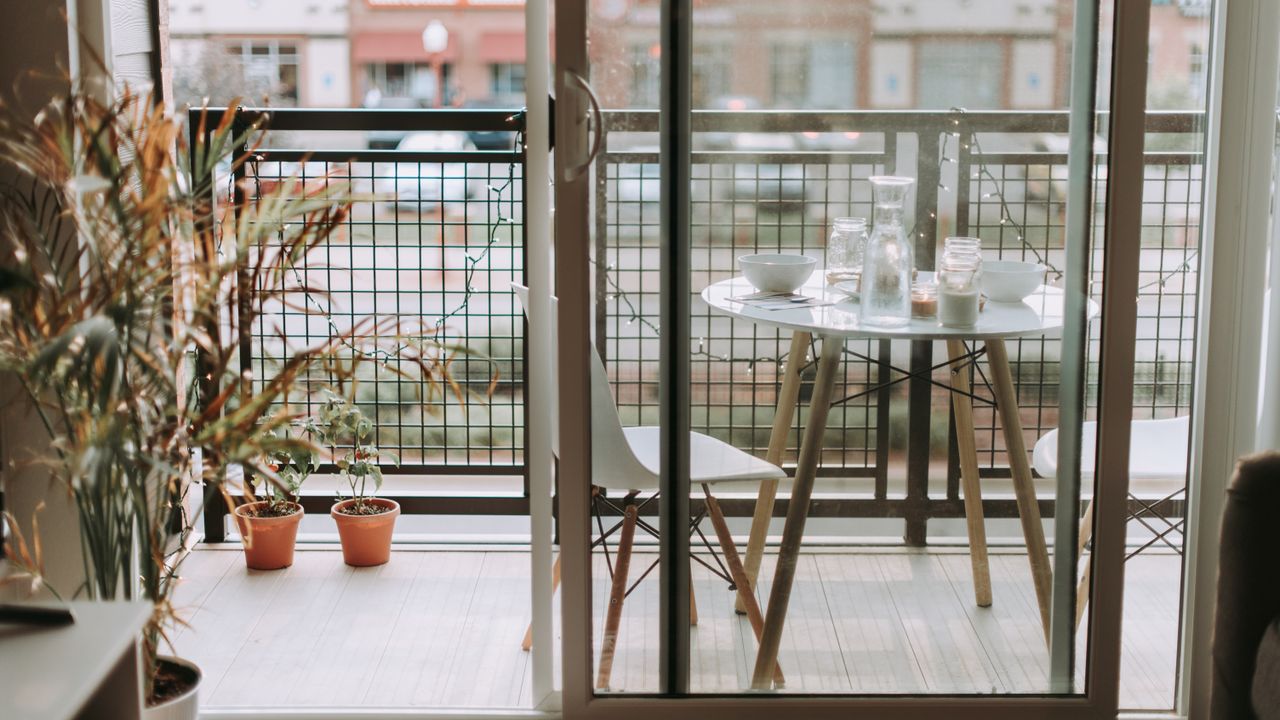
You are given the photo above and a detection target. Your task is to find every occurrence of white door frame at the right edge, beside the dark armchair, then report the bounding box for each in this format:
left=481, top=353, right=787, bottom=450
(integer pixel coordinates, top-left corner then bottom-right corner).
left=1178, top=0, right=1280, bottom=717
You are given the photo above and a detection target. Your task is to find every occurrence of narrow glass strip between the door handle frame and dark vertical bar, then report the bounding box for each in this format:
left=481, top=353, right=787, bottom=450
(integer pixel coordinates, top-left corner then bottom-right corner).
left=586, top=0, right=663, bottom=693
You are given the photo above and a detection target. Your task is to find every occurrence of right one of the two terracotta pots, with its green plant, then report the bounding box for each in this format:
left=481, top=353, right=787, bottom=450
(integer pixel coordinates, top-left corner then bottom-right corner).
left=315, top=393, right=399, bottom=568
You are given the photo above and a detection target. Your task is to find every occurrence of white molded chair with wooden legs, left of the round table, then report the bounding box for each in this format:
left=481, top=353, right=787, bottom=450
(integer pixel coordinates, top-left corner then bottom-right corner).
left=512, top=283, right=786, bottom=689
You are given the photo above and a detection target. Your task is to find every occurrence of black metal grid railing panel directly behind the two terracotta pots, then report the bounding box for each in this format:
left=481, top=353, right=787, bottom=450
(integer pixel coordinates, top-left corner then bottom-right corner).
left=246, top=150, right=525, bottom=471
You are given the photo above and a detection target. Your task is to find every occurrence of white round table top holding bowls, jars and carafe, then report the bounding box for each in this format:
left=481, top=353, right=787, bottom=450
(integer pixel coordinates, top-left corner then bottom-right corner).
left=703, top=270, right=1098, bottom=340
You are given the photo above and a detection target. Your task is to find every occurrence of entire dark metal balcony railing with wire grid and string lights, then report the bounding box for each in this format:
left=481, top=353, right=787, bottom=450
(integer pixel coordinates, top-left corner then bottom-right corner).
left=192, top=110, right=1202, bottom=542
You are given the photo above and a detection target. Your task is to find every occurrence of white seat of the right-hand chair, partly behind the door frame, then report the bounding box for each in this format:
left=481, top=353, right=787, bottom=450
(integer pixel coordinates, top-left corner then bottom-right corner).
left=1032, top=415, right=1190, bottom=480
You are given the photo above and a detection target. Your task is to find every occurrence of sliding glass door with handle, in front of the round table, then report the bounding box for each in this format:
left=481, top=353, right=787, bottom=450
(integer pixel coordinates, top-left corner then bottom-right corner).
left=554, top=0, right=1172, bottom=717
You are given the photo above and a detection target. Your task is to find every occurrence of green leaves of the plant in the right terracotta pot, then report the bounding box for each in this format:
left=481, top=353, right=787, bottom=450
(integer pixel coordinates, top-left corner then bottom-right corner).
left=312, top=391, right=399, bottom=515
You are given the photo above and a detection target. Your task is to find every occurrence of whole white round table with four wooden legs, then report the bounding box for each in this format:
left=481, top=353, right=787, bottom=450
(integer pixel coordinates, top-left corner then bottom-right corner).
left=701, top=272, right=1098, bottom=689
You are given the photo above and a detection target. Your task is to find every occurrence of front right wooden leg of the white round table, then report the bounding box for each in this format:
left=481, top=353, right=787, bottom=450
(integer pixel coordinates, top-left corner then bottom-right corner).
left=987, top=340, right=1053, bottom=642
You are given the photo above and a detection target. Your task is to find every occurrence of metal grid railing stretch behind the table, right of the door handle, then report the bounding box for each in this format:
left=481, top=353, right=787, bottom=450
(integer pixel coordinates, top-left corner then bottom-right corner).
left=596, top=114, right=1201, bottom=486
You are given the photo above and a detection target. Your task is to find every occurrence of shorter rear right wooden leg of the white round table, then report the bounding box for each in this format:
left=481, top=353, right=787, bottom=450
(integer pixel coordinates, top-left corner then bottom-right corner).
left=947, top=340, right=991, bottom=607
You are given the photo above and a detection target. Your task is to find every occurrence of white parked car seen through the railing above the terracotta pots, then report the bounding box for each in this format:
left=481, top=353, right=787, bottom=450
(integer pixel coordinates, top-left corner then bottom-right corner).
left=374, top=131, right=485, bottom=210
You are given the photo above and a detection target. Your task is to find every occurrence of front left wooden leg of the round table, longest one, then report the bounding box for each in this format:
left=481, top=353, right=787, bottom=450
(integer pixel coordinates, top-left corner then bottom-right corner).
left=751, top=337, right=845, bottom=691
